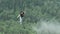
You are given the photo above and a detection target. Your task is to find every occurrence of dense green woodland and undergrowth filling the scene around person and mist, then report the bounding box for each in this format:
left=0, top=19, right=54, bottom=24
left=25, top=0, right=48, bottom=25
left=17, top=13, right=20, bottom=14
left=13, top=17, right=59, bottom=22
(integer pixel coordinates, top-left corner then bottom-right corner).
left=0, top=0, right=60, bottom=34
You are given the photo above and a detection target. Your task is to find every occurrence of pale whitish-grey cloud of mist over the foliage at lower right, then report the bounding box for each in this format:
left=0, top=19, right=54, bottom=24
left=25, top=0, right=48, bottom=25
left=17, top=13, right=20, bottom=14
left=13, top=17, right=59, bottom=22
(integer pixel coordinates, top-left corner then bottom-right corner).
left=32, top=20, right=60, bottom=34
